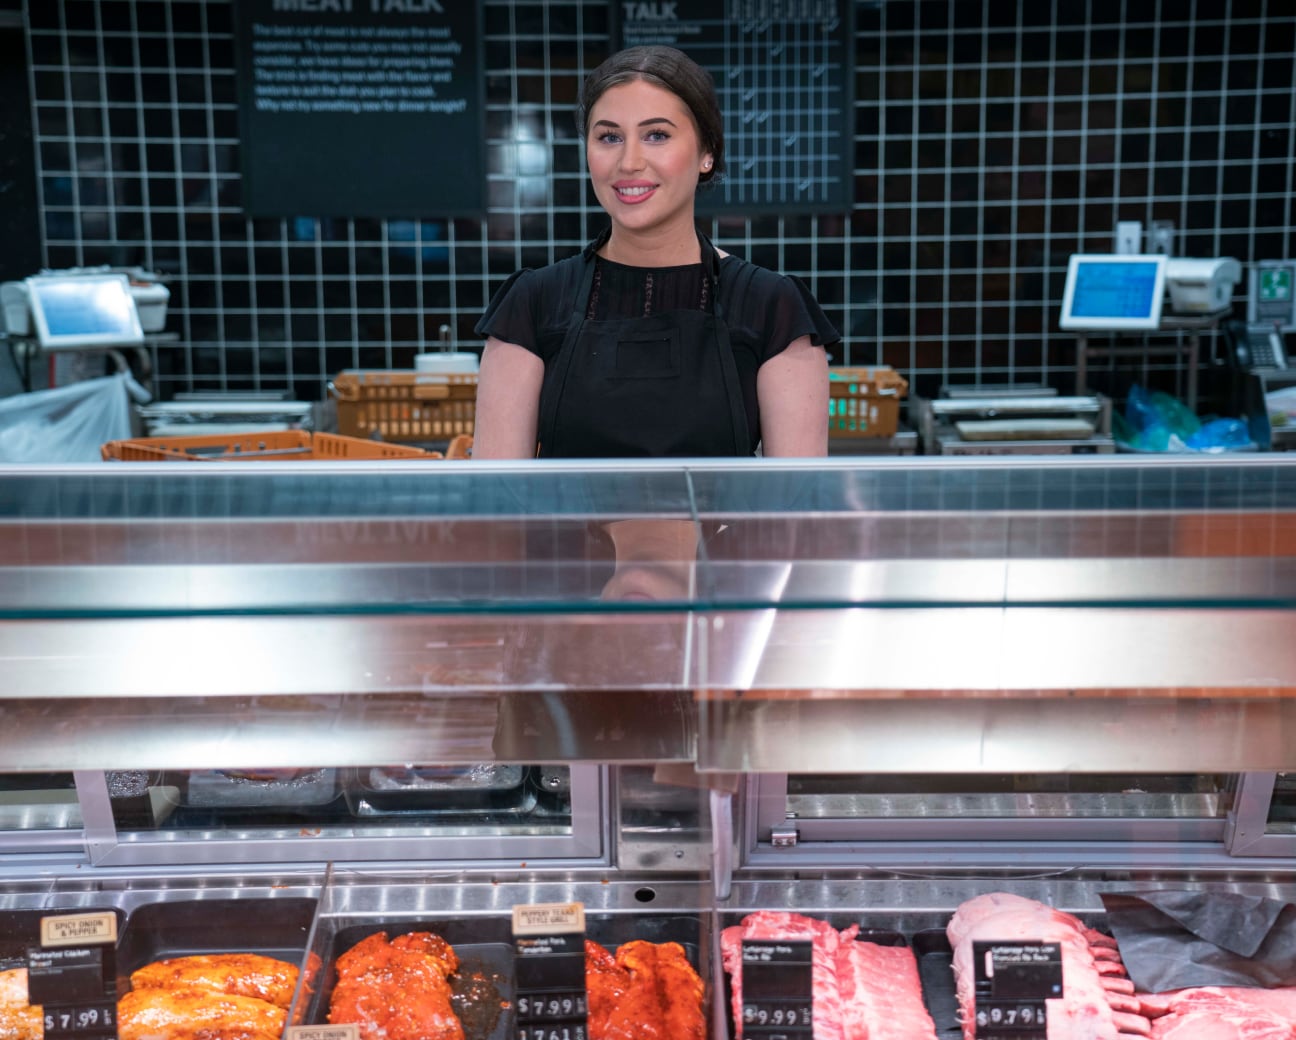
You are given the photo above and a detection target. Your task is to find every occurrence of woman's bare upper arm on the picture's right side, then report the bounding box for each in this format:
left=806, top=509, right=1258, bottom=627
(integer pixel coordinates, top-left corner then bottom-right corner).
left=756, top=336, right=828, bottom=459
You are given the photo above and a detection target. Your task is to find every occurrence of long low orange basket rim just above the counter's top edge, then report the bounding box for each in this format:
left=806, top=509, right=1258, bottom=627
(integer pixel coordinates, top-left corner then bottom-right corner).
left=100, top=429, right=442, bottom=462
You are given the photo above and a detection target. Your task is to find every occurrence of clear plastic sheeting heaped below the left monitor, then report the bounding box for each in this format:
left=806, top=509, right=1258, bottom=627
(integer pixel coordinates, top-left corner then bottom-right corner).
left=0, top=372, right=149, bottom=463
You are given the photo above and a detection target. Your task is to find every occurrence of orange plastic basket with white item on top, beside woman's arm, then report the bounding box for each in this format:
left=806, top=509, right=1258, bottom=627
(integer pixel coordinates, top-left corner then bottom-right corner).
left=329, top=370, right=477, bottom=442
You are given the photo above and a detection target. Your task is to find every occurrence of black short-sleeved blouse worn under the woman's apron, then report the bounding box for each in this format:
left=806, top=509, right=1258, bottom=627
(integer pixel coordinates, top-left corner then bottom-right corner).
left=474, top=254, right=841, bottom=451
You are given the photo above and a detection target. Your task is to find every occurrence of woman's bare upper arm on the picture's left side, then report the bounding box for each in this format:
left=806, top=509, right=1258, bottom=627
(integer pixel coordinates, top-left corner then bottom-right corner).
left=473, top=336, right=544, bottom=459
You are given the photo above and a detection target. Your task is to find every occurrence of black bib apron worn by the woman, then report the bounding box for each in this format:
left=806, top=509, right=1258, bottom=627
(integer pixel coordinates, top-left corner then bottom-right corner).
left=537, top=232, right=752, bottom=459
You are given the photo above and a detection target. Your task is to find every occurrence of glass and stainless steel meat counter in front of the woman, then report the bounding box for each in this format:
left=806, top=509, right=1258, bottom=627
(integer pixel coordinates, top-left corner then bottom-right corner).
left=0, top=458, right=1296, bottom=1036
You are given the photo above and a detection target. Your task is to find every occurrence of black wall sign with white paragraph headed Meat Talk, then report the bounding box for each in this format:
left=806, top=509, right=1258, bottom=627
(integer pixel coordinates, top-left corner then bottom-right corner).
left=235, top=0, right=486, bottom=218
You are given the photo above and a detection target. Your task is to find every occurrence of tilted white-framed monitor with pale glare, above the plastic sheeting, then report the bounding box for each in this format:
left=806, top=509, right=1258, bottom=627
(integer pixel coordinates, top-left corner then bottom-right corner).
left=23, top=274, right=144, bottom=350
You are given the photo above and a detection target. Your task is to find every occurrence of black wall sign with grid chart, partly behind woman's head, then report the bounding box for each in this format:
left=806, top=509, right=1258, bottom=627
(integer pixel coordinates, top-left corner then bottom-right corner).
left=612, top=0, right=854, bottom=214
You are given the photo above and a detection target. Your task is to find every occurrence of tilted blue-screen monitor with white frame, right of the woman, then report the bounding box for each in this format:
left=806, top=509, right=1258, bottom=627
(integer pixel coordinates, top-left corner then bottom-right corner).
left=1058, top=253, right=1166, bottom=329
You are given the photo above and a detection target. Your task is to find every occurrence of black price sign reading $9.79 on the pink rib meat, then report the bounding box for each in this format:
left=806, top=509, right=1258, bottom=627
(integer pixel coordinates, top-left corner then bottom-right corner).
left=972, top=941, right=1063, bottom=1040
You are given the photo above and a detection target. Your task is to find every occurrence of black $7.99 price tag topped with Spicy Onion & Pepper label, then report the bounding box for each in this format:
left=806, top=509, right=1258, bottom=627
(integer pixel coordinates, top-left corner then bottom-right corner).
left=27, top=912, right=117, bottom=1040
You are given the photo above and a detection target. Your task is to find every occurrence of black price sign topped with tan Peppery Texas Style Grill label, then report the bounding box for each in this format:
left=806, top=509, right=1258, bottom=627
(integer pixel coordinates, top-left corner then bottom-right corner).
left=513, top=903, right=590, bottom=1040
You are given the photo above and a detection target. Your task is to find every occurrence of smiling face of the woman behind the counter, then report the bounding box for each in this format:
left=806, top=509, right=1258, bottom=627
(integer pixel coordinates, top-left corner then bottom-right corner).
left=586, top=79, right=710, bottom=233
